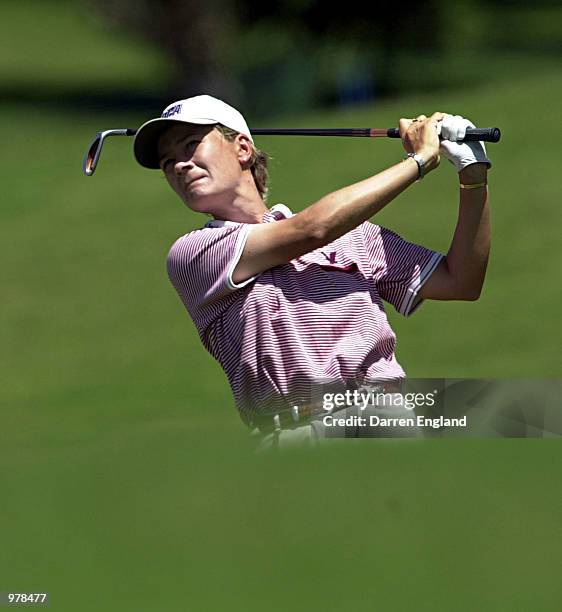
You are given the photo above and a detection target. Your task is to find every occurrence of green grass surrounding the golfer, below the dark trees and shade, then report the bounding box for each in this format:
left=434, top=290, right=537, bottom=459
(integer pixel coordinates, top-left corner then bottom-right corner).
left=0, top=53, right=562, bottom=611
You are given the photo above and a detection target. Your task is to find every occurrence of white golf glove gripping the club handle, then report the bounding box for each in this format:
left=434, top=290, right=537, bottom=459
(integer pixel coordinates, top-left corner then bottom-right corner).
left=438, top=115, right=492, bottom=172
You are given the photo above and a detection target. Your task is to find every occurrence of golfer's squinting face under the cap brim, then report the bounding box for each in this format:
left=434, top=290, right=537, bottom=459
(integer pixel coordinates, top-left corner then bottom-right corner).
left=158, top=124, right=246, bottom=214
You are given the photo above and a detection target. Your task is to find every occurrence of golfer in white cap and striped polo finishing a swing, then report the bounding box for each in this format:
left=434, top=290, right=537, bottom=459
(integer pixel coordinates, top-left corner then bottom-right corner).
left=130, top=95, right=491, bottom=442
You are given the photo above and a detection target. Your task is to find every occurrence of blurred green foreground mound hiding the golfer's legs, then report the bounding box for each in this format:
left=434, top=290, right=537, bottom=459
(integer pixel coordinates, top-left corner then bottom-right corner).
left=0, top=438, right=561, bottom=612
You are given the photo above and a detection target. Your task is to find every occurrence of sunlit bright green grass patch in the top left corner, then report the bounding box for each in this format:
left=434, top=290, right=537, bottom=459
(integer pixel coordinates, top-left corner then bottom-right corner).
left=0, top=0, right=169, bottom=95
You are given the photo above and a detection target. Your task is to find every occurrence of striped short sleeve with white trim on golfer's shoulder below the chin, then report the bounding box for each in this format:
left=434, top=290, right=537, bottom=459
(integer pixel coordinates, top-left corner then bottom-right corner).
left=166, top=224, right=255, bottom=330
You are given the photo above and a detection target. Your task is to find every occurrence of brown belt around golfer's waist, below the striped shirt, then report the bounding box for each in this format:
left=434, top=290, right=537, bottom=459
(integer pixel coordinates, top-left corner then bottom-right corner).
left=244, top=381, right=403, bottom=434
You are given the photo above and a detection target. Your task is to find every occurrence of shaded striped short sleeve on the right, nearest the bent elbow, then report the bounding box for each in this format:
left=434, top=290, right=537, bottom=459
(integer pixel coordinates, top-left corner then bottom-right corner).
left=362, top=222, right=443, bottom=316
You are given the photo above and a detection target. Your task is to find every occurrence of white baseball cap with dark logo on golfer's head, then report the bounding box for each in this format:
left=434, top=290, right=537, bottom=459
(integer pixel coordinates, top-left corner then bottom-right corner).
left=133, top=95, right=254, bottom=169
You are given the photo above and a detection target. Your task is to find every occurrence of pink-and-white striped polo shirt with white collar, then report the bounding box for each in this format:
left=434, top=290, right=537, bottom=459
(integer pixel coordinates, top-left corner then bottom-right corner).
left=167, top=204, right=443, bottom=422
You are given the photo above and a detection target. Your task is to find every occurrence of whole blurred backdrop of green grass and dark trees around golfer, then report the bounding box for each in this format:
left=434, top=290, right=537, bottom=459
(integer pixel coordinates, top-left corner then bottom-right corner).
left=0, top=0, right=562, bottom=611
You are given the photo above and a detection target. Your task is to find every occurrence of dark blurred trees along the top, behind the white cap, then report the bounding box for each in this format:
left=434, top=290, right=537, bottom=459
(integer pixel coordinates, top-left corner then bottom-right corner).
left=82, top=0, right=560, bottom=113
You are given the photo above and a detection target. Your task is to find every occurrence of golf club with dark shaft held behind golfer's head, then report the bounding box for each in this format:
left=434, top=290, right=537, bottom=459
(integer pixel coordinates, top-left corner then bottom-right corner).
left=82, top=128, right=501, bottom=176
